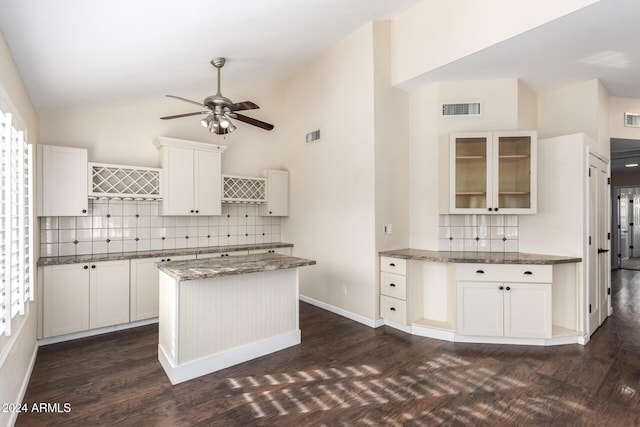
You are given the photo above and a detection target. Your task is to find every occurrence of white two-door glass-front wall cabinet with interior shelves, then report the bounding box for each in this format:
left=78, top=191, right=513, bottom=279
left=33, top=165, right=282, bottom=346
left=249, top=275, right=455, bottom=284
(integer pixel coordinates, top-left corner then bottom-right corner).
left=449, top=131, right=537, bottom=214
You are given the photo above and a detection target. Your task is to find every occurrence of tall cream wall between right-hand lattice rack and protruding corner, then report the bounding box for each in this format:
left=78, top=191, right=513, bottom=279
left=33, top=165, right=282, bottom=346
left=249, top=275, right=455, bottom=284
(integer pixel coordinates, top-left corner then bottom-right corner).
left=280, top=24, right=377, bottom=319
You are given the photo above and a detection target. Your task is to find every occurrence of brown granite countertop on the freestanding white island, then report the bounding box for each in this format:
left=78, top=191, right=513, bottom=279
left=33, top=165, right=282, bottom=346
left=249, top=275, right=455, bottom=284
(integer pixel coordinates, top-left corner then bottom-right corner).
left=158, top=254, right=316, bottom=282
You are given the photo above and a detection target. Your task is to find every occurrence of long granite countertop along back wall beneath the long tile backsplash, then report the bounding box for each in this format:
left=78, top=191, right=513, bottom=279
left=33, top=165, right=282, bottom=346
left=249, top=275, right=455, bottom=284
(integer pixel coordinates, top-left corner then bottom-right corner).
left=38, top=242, right=293, bottom=266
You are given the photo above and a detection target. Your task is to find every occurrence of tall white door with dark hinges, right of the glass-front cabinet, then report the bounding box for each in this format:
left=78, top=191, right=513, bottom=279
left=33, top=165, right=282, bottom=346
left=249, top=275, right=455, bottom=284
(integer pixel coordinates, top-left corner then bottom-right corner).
left=587, top=155, right=611, bottom=334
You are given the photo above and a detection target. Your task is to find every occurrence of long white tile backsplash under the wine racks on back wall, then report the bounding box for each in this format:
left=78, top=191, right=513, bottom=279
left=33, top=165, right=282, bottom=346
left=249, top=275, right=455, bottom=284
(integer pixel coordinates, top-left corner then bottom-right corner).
left=40, top=200, right=280, bottom=256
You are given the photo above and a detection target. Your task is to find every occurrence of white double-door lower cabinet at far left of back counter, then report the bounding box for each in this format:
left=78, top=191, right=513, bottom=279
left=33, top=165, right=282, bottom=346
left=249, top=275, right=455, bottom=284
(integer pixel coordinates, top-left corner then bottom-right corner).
left=43, top=260, right=129, bottom=338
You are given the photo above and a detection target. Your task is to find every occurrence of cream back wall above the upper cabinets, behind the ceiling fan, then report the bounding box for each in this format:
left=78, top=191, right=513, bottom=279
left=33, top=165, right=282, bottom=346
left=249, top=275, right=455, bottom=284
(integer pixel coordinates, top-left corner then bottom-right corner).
left=40, top=88, right=281, bottom=176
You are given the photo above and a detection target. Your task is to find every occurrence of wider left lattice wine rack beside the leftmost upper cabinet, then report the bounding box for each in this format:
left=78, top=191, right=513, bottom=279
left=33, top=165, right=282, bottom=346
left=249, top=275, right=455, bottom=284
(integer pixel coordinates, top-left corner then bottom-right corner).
left=89, top=163, right=162, bottom=200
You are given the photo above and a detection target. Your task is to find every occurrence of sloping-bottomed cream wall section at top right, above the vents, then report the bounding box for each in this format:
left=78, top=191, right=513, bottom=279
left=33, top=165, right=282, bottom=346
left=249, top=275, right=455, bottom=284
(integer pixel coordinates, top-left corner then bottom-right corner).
left=391, top=0, right=597, bottom=85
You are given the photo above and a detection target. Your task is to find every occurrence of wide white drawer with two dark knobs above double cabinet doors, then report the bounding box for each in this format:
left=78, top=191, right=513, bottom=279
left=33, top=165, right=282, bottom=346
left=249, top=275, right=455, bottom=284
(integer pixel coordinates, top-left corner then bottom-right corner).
left=456, top=264, right=553, bottom=283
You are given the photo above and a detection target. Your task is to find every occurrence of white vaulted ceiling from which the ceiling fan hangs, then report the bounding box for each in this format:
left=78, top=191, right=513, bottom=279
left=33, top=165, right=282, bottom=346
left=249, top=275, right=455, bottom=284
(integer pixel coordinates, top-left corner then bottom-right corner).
left=0, top=0, right=418, bottom=111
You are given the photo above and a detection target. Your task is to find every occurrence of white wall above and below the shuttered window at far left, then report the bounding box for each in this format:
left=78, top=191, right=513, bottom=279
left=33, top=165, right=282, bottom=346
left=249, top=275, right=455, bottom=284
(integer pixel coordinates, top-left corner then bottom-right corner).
left=0, top=33, right=39, bottom=425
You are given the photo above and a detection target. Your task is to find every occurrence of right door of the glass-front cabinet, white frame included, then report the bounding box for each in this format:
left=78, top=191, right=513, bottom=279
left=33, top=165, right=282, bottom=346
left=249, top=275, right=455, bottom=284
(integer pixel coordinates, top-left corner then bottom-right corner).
left=491, top=132, right=537, bottom=214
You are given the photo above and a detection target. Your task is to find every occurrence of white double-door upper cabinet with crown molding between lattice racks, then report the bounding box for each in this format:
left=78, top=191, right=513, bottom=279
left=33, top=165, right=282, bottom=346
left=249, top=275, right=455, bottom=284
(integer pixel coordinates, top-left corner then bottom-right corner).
left=155, top=137, right=227, bottom=215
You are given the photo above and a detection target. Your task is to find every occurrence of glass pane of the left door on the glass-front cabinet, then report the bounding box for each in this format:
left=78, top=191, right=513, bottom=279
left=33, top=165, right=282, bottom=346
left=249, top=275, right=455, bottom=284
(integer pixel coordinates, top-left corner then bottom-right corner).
left=455, top=136, right=489, bottom=209
